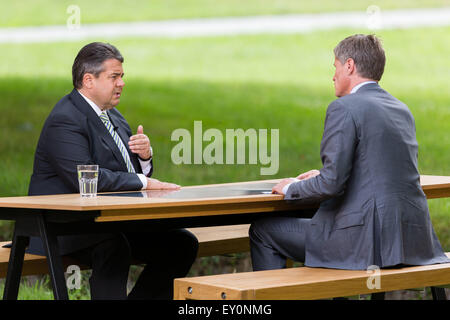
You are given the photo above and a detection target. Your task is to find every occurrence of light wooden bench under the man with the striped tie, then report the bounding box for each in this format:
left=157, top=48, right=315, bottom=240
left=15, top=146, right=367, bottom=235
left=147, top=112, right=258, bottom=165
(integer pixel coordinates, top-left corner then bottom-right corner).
left=0, top=224, right=250, bottom=278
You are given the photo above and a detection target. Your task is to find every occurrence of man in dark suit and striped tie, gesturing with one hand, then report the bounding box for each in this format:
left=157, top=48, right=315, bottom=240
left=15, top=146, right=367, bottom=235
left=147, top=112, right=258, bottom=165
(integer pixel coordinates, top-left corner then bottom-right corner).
left=29, top=42, right=198, bottom=299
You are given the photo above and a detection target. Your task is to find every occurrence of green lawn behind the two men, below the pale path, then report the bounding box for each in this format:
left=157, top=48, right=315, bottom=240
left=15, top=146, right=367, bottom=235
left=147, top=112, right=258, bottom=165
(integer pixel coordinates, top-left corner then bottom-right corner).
left=0, top=28, right=450, bottom=298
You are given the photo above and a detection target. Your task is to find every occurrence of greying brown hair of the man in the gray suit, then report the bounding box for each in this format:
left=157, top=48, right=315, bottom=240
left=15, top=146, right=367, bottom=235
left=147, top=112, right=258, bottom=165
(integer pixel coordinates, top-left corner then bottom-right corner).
left=334, top=34, right=386, bottom=81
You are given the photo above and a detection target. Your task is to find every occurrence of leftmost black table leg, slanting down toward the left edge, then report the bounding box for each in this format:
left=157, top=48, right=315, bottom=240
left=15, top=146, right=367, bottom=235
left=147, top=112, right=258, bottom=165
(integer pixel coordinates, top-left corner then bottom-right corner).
left=3, top=234, right=30, bottom=300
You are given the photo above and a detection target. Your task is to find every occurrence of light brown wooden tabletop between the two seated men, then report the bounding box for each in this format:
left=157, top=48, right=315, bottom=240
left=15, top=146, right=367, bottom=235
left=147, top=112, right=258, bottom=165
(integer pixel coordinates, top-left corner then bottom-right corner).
left=0, top=175, right=450, bottom=221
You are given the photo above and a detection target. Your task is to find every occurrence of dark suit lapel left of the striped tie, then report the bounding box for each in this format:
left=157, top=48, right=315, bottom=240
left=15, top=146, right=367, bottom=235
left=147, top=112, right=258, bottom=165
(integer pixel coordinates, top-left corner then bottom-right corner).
left=69, top=89, right=129, bottom=171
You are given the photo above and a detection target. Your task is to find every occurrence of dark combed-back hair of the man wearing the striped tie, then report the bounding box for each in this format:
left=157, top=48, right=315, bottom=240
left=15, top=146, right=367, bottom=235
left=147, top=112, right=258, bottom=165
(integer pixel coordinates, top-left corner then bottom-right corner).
left=72, top=42, right=124, bottom=89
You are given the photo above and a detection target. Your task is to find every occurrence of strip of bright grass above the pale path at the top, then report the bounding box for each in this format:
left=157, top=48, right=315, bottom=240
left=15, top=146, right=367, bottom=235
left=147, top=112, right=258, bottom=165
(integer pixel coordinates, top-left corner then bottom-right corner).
left=0, top=0, right=450, bottom=27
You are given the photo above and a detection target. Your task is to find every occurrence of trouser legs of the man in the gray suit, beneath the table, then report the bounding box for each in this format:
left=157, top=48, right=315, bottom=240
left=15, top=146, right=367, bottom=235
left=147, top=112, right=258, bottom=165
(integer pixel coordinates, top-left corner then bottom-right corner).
left=249, top=216, right=311, bottom=271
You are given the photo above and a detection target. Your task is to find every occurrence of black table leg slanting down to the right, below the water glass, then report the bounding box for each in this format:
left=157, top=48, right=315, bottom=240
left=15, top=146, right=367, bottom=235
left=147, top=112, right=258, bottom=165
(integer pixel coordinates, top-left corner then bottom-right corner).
left=38, top=215, right=69, bottom=300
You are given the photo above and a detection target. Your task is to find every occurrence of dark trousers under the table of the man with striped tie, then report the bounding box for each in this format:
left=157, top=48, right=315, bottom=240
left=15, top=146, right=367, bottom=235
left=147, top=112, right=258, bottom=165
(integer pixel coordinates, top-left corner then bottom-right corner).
left=69, top=229, right=198, bottom=300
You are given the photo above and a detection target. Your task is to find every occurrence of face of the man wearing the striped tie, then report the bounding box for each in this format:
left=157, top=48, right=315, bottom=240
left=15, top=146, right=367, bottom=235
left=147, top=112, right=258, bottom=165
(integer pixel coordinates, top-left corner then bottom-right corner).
left=90, top=59, right=125, bottom=110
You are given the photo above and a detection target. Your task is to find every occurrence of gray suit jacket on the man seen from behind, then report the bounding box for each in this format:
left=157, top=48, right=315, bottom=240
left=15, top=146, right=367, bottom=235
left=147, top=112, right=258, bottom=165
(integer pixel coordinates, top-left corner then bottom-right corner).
left=285, top=83, right=450, bottom=270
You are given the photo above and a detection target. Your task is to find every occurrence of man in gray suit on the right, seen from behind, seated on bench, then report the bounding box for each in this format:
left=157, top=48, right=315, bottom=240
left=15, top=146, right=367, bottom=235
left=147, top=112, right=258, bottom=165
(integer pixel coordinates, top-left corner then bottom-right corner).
left=250, top=34, right=449, bottom=271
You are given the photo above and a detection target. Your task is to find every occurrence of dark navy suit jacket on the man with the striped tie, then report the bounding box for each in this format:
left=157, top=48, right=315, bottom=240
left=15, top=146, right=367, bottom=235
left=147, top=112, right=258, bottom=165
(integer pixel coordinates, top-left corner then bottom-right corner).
left=28, top=89, right=153, bottom=254
